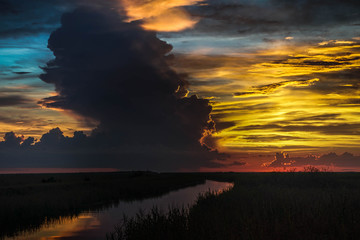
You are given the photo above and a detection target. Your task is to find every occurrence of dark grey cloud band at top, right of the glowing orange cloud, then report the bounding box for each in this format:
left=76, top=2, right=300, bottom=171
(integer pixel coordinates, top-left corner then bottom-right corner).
left=188, top=0, right=360, bottom=34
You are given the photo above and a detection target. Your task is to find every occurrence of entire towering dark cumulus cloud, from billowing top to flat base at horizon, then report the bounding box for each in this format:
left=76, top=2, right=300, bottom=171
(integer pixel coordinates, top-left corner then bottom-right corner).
left=0, top=8, right=222, bottom=170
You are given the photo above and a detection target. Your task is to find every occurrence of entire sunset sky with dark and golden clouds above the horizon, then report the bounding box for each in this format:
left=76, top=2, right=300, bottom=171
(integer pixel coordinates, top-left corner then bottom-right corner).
left=0, top=0, right=360, bottom=172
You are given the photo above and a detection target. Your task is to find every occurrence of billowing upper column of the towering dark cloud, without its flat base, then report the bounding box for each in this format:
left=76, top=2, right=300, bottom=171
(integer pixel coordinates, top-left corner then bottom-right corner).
left=40, top=9, right=212, bottom=145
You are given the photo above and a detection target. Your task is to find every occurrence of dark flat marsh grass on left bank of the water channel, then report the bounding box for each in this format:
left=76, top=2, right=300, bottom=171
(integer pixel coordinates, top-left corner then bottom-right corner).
left=0, top=172, right=205, bottom=239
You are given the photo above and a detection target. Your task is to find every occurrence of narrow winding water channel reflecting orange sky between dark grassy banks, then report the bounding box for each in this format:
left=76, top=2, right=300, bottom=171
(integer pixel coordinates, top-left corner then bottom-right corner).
left=6, top=180, right=233, bottom=240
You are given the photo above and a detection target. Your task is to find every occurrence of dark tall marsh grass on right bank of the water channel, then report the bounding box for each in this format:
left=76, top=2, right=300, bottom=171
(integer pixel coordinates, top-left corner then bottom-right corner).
left=107, top=173, right=360, bottom=240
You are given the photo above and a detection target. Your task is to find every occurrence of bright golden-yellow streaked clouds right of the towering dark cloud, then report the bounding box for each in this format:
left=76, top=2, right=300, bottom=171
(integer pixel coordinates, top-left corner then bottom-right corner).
left=175, top=39, right=360, bottom=154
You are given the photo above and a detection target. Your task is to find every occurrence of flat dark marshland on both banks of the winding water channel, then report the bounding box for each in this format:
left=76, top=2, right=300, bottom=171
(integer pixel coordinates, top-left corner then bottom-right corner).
left=0, top=170, right=360, bottom=240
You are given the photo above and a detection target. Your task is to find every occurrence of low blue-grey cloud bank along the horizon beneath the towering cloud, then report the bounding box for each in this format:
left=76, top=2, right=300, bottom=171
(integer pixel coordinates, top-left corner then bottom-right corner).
left=0, top=128, right=227, bottom=171
